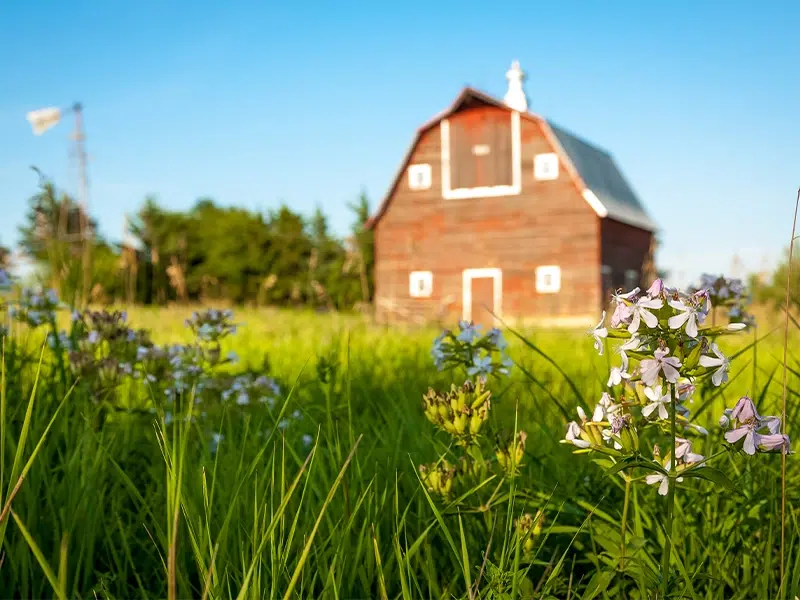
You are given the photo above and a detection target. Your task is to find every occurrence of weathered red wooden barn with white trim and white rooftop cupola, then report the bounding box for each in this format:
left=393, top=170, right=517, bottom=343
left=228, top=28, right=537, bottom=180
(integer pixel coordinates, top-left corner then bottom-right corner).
left=368, top=61, right=655, bottom=326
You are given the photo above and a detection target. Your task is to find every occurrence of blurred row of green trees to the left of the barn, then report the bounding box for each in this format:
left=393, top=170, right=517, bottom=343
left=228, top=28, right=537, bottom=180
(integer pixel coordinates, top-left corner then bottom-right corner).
left=7, top=171, right=373, bottom=310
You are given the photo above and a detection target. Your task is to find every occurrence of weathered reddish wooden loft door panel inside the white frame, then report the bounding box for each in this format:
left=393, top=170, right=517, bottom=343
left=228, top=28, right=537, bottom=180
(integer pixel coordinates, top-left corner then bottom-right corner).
left=450, top=110, right=514, bottom=189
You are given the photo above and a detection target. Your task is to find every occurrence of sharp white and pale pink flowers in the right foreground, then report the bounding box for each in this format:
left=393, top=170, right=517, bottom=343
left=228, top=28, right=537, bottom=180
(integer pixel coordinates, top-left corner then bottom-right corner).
left=562, top=278, right=789, bottom=494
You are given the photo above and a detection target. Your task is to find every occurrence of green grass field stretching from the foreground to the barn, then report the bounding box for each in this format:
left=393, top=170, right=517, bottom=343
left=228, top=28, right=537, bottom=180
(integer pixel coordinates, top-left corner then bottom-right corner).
left=0, top=308, right=800, bottom=600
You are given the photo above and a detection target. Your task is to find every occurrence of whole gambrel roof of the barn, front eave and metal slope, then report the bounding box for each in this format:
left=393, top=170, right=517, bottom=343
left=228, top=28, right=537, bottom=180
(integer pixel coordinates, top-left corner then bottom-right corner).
left=367, top=87, right=657, bottom=232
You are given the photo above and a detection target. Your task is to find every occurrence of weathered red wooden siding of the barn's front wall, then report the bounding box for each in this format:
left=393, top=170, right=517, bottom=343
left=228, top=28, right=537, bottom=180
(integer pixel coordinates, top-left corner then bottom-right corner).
left=374, top=106, right=601, bottom=322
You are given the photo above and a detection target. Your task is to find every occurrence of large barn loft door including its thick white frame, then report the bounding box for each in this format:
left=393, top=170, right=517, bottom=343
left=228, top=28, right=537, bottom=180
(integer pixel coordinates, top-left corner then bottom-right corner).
left=441, top=108, right=521, bottom=199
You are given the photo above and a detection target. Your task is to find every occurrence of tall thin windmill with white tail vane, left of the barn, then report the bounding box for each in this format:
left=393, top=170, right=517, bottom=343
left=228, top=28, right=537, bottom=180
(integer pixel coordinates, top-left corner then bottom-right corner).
left=26, top=102, right=94, bottom=304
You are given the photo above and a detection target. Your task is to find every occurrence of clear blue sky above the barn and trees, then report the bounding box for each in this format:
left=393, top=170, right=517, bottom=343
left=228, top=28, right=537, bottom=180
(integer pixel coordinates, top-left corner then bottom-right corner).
left=0, top=0, right=800, bottom=284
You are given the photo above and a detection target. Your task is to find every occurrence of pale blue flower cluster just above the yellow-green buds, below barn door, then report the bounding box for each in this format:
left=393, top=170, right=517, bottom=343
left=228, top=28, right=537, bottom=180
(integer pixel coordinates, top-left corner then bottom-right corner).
left=431, top=321, right=513, bottom=377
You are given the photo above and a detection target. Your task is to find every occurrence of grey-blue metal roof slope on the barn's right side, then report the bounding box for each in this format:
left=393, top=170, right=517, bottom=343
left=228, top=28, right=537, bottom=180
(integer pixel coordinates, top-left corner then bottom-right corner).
left=547, top=121, right=657, bottom=231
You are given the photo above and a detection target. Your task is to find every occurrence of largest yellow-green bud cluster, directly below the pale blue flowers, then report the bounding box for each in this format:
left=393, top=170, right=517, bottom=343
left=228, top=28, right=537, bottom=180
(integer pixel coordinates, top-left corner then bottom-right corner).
left=422, top=378, right=492, bottom=446
